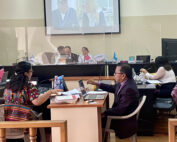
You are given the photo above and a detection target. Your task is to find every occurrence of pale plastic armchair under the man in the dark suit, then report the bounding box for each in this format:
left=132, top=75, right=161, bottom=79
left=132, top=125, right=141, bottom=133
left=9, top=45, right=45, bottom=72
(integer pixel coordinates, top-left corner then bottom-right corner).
left=103, top=96, right=146, bottom=142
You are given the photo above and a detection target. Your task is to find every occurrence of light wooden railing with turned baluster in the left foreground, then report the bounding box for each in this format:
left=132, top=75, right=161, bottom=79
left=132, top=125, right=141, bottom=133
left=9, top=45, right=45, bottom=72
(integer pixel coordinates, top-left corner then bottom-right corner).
left=0, top=120, right=67, bottom=142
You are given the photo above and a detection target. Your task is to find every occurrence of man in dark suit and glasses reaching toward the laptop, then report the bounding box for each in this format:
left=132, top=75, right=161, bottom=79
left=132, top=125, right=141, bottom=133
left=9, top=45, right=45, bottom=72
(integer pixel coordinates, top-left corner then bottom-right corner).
left=87, top=64, right=139, bottom=138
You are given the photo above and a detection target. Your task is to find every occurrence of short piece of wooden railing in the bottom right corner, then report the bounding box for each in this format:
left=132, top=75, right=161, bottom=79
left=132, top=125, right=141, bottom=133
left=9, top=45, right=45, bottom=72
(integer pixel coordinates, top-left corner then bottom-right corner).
left=168, top=119, right=177, bottom=142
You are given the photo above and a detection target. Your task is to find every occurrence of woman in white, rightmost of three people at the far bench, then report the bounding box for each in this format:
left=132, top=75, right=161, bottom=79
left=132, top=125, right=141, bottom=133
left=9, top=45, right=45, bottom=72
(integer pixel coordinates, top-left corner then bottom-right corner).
left=79, top=47, right=94, bottom=63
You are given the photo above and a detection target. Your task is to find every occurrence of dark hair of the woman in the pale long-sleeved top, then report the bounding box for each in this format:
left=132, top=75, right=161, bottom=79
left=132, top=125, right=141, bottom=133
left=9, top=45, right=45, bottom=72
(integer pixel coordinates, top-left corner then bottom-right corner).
left=155, top=56, right=172, bottom=71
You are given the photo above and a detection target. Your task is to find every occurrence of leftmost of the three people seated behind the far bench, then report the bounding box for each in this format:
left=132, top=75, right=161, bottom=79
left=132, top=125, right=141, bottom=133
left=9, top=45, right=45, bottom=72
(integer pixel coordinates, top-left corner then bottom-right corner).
left=53, top=46, right=66, bottom=64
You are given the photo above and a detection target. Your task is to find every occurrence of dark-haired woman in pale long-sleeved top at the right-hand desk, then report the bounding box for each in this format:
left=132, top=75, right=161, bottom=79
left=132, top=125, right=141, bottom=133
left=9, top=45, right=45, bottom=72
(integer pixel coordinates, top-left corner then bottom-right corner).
left=140, top=56, right=176, bottom=97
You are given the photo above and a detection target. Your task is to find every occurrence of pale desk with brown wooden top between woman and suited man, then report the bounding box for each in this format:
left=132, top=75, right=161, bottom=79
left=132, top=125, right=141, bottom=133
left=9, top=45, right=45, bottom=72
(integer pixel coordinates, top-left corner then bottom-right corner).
left=48, top=95, right=107, bottom=142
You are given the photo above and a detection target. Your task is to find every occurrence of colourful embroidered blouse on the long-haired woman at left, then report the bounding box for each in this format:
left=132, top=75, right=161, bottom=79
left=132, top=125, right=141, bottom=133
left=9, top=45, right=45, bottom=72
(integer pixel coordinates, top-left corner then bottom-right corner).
left=4, top=83, right=40, bottom=105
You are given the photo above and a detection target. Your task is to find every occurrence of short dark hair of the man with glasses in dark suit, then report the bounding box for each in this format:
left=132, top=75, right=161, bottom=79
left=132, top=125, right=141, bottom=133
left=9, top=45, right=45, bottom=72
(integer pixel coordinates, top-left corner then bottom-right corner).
left=117, top=63, right=132, bottom=79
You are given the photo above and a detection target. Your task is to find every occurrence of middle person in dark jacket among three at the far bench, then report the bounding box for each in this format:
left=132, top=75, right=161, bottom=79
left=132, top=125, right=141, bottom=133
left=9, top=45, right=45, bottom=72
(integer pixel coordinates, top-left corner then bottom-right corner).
left=65, top=46, right=78, bottom=63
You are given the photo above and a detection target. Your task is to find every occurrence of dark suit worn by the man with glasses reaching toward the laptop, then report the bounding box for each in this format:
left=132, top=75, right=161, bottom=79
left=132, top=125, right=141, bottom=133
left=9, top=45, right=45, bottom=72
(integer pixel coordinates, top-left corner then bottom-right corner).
left=100, top=79, right=139, bottom=138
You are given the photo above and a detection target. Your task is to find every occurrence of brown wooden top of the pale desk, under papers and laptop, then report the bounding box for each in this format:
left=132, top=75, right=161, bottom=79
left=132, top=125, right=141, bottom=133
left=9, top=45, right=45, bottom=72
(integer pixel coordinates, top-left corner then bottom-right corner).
left=47, top=95, right=108, bottom=109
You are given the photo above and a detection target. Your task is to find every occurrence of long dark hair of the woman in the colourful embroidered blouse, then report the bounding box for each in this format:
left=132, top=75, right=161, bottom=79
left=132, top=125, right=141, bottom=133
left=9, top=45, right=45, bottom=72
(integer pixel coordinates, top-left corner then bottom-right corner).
left=6, top=61, right=31, bottom=92
